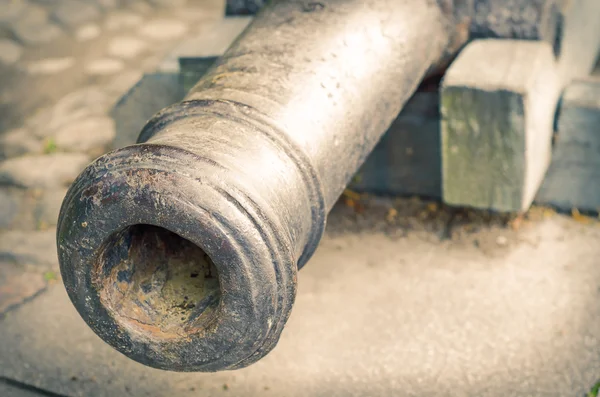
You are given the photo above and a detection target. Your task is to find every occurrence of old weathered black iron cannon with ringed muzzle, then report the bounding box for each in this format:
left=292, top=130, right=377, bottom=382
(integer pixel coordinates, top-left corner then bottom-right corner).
left=57, top=0, right=600, bottom=372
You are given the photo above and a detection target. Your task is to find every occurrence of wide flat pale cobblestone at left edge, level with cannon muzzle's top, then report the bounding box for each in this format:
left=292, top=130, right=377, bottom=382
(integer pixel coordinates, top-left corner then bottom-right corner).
left=0, top=153, right=89, bottom=188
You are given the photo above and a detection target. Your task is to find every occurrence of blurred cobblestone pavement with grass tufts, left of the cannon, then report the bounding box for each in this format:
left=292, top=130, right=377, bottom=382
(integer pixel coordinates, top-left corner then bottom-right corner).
left=0, top=0, right=224, bottom=314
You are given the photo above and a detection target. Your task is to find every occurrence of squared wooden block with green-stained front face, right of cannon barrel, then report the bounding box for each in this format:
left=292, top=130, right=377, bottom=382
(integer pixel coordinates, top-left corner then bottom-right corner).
left=441, top=40, right=560, bottom=212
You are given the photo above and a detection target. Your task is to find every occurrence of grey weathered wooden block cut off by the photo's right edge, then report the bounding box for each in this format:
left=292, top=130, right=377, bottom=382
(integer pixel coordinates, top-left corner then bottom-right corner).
left=537, top=78, right=600, bottom=211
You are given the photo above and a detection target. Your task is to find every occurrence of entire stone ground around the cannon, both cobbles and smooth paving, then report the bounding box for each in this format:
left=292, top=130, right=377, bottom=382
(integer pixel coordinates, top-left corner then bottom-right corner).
left=0, top=0, right=600, bottom=397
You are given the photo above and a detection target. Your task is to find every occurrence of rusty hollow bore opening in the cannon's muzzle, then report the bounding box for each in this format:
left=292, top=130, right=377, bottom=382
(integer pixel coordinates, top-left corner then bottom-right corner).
left=93, top=224, right=221, bottom=340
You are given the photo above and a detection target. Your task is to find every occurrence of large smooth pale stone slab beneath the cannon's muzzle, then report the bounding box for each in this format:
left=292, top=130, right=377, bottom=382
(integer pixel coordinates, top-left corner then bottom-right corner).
left=0, top=208, right=600, bottom=397
